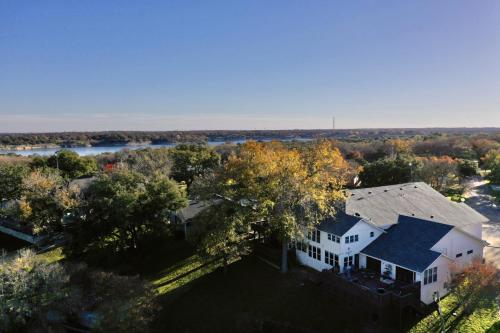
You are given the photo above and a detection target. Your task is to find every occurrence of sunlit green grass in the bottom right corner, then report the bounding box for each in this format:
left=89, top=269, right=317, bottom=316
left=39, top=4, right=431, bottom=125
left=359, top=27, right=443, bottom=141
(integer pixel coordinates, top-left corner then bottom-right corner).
left=410, top=282, right=500, bottom=333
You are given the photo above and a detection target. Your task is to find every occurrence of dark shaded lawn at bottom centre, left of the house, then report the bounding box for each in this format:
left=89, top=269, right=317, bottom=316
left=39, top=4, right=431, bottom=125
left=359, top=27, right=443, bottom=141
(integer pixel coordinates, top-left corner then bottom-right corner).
left=150, top=250, right=374, bottom=332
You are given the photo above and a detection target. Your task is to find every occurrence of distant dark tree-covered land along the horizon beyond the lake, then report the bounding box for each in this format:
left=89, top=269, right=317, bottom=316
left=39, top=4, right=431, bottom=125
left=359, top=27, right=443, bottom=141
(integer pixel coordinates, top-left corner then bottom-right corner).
left=0, top=127, right=500, bottom=152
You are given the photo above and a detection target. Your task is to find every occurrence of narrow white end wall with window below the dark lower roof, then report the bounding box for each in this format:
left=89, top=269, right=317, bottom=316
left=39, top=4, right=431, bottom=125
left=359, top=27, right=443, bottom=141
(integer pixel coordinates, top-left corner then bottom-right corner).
left=417, top=256, right=451, bottom=304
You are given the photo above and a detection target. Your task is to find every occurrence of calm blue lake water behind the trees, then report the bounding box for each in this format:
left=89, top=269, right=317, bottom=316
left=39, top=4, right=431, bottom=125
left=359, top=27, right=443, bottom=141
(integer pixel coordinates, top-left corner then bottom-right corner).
left=0, top=138, right=310, bottom=156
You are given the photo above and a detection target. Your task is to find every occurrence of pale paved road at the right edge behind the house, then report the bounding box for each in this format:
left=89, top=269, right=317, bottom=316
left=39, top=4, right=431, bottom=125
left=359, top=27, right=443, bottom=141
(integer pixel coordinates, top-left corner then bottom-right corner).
left=466, top=179, right=500, bottom=268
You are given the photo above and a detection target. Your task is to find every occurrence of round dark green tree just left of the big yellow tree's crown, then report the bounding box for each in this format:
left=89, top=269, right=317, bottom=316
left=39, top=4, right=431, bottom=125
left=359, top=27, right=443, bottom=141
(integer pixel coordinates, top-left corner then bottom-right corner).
left=170, top=144, right=220, bottom=186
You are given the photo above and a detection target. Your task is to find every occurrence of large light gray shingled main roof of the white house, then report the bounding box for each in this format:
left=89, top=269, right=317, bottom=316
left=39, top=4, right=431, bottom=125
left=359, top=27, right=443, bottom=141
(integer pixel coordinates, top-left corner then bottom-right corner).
left=346, top=182, right=488, bottom=228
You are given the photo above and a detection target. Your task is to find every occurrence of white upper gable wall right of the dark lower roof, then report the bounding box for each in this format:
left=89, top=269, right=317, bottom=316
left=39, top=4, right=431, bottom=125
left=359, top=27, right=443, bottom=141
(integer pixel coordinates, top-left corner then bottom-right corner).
left=432, top=228, right=483, bottom=266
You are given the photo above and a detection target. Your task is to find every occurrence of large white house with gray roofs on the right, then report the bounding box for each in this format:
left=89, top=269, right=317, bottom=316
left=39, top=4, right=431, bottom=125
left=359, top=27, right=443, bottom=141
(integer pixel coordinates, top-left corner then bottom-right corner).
left=296, top=182, right=487, bottom=304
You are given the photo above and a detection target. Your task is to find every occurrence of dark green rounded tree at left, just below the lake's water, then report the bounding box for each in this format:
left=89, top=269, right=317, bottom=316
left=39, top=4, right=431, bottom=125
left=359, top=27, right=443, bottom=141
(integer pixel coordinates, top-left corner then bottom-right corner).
left=47, top=149, right=97, bottom=179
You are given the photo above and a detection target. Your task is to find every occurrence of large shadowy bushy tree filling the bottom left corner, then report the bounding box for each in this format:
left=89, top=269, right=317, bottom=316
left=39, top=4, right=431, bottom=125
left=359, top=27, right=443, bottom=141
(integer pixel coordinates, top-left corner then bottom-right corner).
left=0, top=250, right=160, bottom=333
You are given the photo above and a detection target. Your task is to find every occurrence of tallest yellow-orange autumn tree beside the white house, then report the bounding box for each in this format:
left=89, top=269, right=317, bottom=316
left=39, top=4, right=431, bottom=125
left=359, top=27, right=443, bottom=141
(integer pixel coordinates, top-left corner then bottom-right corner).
left=193, top=141, right=350, bottom=272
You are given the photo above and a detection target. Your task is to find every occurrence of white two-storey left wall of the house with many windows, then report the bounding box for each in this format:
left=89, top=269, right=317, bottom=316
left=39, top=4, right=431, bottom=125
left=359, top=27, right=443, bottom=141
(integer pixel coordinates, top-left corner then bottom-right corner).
left=296, top=221, right=382, bottom=272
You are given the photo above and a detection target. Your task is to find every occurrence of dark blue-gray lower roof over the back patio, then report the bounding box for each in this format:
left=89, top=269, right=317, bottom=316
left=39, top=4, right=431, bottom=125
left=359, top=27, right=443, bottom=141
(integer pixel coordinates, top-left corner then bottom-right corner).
left=361, top=216, right=453, bottom=272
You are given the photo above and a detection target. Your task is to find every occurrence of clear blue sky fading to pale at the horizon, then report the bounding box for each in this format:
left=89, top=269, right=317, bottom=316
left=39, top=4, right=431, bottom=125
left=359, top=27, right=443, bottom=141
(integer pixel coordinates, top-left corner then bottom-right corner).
left=0, top=0, right=500, bottom=132
